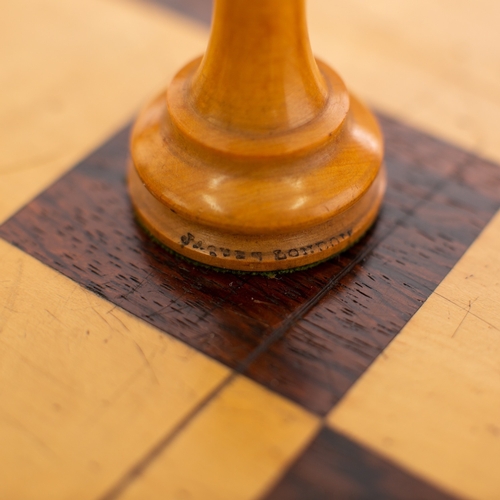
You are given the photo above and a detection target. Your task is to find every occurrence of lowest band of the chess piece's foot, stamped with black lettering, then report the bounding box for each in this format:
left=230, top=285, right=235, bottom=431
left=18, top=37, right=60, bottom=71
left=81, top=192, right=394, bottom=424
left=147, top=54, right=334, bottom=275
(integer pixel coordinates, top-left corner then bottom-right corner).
left=129, top=162, right=385, bottom=272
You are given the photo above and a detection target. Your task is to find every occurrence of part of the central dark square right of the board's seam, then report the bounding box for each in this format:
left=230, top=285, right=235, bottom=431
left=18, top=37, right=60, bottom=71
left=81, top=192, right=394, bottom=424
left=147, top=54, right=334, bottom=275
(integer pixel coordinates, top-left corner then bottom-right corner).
left=246, top=115, right=500, bottom=414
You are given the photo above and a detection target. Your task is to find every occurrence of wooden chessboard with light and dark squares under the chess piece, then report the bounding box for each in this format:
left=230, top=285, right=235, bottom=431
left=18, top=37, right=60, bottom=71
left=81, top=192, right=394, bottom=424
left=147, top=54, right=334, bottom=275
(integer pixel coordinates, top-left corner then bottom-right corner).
left=0, top=0, right=500, bottom=500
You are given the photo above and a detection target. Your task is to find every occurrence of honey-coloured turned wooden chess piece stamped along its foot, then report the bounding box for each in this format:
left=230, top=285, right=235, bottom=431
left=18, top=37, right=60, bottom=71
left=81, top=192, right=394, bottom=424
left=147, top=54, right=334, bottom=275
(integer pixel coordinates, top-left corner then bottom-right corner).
left=129, top=0, right=386, bottom=271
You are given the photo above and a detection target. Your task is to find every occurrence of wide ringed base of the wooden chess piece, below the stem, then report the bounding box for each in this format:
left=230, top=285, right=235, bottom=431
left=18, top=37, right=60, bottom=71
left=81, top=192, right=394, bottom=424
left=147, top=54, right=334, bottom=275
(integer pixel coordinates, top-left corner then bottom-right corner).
left=129, top=61, right=386, bottom=272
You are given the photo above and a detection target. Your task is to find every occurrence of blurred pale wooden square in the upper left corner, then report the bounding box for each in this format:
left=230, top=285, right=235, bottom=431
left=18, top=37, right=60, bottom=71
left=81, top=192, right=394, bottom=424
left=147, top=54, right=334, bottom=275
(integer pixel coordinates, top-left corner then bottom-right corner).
left=0, top=0, right=207, bottom=225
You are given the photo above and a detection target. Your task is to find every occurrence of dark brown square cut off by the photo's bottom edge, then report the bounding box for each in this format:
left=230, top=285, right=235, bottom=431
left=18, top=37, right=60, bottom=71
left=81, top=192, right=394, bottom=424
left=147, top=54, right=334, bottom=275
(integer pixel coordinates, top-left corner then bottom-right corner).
left=266, top=429, right=460, bottom=500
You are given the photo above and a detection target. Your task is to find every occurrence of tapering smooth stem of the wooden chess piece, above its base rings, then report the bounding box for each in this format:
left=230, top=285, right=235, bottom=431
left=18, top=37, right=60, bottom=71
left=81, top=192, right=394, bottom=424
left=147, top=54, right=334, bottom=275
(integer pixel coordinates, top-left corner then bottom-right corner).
left=191, top=0, right=328, bottom=134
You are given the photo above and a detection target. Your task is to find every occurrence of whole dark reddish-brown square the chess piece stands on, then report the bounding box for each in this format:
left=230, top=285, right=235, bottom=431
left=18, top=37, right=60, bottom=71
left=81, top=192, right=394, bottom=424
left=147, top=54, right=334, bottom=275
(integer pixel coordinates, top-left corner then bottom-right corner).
left=0, top=114, right=500, bottom=414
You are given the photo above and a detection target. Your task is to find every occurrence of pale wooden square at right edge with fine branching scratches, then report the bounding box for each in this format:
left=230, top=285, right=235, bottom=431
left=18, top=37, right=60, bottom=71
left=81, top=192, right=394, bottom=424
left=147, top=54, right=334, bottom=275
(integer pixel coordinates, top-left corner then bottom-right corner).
left=329, top=213, right=500, bottom=499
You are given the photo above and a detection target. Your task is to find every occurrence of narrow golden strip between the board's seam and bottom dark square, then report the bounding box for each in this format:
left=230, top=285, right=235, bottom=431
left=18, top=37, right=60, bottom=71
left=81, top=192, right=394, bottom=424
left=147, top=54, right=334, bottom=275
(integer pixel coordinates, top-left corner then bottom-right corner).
left=110, top=377, right=319, bottom=500
